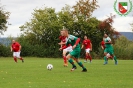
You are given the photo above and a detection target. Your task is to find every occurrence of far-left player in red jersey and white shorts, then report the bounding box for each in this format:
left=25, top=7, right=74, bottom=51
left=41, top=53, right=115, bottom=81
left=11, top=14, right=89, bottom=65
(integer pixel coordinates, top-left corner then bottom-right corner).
left=11, top=40, right=24, bottom=63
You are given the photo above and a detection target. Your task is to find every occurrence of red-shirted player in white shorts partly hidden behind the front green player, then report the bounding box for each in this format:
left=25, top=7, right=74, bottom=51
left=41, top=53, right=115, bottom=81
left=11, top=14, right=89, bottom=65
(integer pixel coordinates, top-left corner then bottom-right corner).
left=58, top=31, right=72, bottom=67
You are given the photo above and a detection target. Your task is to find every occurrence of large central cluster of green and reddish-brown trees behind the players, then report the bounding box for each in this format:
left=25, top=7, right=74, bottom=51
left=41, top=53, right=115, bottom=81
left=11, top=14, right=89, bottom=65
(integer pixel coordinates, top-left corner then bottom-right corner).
left=0, top=0, right=133, bottom=57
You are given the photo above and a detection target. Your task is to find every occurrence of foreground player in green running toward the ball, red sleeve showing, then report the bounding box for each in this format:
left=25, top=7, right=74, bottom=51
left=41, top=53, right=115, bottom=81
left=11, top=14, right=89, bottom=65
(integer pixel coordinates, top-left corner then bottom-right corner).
left=62, top=29, right=87, bottom=72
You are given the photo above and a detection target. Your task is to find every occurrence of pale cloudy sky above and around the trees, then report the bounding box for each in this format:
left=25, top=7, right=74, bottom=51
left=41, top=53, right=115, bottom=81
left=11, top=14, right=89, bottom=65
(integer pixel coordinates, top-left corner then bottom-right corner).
left=0, top=0, right=133, bottom=37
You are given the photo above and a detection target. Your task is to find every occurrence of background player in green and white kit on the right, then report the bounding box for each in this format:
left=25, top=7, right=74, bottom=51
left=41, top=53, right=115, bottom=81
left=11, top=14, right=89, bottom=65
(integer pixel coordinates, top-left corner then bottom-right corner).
left=104, top=33, right=118, bottom=65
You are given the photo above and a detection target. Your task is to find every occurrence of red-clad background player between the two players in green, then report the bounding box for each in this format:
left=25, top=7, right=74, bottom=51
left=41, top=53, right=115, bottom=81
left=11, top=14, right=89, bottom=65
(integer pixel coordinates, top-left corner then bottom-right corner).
left=81, top=35, right=92, bottom=63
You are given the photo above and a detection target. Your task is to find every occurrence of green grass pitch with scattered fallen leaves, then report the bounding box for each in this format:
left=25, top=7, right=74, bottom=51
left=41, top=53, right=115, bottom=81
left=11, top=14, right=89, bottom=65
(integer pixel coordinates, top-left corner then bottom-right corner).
left=0, top=57, right=133, bottom=88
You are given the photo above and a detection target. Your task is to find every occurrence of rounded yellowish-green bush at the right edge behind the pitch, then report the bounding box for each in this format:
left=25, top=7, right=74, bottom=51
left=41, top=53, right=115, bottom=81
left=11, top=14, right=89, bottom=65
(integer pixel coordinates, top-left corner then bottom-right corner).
left=114, top=36, right=133, bottom=59
